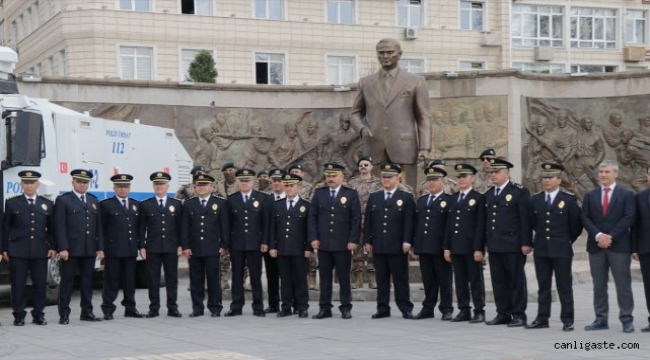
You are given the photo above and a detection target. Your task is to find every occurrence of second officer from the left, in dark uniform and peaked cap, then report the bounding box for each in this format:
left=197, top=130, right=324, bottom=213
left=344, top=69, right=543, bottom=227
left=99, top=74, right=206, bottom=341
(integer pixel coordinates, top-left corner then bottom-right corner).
left=54, top=169, right=104, bottom=325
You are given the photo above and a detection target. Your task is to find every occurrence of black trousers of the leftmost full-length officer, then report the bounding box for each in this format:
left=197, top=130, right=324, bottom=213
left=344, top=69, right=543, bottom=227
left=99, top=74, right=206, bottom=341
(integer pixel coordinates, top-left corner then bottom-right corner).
left=9, top=256, right=47, bottom=319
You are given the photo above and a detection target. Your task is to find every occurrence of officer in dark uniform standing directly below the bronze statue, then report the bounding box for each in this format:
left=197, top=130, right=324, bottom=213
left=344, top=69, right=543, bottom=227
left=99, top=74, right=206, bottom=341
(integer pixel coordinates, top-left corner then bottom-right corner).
left=363, top=164, right=415, bottom=319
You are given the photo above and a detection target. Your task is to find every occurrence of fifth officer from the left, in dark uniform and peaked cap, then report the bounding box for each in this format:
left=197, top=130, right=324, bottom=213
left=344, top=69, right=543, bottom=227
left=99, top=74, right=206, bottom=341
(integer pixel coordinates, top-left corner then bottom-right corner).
left=181, top=174, right=230, bottom=317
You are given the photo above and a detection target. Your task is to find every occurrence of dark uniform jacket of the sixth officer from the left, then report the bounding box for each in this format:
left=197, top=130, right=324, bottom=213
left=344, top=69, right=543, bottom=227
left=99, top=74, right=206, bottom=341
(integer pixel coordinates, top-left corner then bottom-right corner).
left=227, top=190, right=273, bottom=251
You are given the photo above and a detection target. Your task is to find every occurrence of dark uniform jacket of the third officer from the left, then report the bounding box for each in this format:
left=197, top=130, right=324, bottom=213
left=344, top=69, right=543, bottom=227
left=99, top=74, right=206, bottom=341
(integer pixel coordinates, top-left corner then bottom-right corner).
left=99, top=196, right=141, bottom=258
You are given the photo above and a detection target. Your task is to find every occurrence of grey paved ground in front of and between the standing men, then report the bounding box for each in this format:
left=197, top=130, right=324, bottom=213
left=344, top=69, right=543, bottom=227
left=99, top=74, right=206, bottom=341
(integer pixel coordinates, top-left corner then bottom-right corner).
left=0, top=272, right=650, bottom=360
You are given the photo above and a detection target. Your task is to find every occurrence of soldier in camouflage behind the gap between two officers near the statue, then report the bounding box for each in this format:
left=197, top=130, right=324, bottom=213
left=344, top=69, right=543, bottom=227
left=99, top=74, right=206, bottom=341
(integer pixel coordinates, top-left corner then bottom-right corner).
left=349, top=155, right=382, bottom=289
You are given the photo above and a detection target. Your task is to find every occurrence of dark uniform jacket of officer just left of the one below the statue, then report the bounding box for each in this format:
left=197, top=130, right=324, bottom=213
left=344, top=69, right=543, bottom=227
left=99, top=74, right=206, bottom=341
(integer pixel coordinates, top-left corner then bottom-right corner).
left=309, top=186, right=361, bottom=251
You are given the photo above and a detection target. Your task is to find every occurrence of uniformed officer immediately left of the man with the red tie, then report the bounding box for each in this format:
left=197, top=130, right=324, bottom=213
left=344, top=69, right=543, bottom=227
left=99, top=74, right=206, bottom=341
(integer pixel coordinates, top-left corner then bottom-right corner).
left=526, top=163, right=582, bottom=331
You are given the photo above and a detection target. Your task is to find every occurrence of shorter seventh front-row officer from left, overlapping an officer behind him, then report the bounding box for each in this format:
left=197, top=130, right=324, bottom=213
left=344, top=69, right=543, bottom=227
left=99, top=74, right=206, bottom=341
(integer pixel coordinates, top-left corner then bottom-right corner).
left=268, top=174, right=313, bottom=318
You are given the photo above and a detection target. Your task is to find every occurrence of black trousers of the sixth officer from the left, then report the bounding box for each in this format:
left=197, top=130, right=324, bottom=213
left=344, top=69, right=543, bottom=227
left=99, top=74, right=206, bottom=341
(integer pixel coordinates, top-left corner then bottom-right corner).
left=230, top=250, right=264, bottom=312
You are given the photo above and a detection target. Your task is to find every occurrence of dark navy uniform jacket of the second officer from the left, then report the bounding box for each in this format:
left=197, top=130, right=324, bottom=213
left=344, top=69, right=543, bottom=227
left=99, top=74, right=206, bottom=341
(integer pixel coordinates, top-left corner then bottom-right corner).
left=54, top=191, right=104, bottom=256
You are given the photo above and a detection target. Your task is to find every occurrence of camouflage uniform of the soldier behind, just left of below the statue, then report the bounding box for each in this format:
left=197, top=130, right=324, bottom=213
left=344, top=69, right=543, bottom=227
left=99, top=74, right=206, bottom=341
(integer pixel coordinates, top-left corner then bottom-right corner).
left=348, top=175, right=382, bottom=289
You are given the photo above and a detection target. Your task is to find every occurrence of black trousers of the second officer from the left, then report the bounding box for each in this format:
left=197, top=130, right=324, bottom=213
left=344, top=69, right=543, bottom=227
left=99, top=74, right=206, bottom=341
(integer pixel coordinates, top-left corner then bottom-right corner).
left=59, top=256, right=96, bottom=317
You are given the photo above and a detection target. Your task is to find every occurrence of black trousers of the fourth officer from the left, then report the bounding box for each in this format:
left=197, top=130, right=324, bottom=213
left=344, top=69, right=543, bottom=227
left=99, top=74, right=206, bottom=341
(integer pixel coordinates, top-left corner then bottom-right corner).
left=145, top=252, right=178, bottom=311
